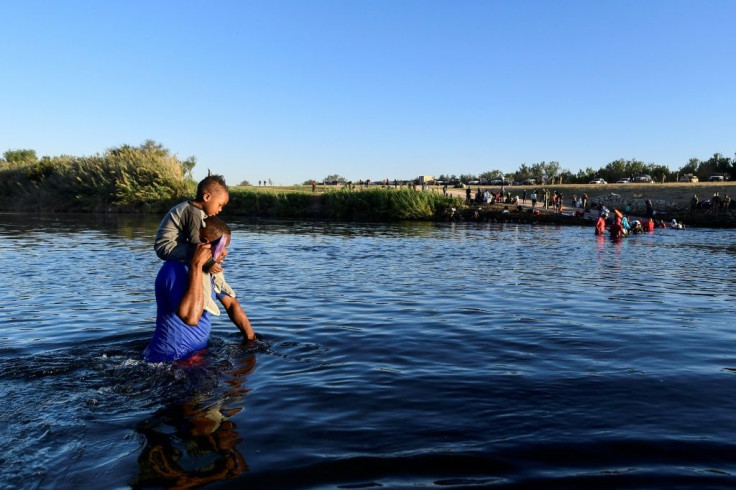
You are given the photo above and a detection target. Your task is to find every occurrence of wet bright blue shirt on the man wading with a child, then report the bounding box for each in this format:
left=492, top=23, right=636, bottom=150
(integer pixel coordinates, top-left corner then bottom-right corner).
left=143, top=260, right=221, bottom=362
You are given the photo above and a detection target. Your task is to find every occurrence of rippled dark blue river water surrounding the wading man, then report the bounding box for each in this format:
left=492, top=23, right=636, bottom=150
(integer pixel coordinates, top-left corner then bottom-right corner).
left=0, top=215, right=736, bottom=488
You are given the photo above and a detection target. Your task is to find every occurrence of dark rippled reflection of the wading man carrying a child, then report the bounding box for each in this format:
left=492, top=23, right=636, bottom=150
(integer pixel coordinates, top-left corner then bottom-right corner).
left=133, top=355, right=256, bottom=488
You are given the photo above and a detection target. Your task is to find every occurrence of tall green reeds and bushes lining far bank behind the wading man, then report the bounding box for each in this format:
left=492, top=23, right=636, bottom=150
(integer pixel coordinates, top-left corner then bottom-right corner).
left=0, top=154, right=462, bottom=221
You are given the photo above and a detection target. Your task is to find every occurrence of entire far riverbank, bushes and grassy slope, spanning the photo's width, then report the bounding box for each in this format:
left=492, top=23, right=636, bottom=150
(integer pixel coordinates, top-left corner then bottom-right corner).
left=0, top=153, right=736, bottom=227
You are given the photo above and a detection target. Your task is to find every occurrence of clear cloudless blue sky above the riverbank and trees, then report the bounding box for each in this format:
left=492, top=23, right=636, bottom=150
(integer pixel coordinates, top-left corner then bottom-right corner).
left=0, top=0, right=736, bottom=185
